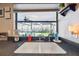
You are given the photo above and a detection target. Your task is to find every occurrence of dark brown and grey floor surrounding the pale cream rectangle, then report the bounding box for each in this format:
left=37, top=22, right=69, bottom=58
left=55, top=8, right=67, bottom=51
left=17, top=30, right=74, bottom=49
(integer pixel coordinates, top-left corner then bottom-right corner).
left=0, top=41, right=79, bottom=56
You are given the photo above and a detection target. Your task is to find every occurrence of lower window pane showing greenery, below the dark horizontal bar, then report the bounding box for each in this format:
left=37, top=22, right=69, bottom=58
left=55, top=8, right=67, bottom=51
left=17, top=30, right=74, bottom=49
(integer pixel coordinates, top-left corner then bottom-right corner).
left=17, top=22, right=56, bottom=36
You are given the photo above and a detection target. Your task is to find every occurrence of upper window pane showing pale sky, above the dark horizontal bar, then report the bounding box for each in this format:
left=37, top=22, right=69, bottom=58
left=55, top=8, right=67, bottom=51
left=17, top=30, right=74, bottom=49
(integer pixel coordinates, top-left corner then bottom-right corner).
left=18, top=12, right=56, bottom=21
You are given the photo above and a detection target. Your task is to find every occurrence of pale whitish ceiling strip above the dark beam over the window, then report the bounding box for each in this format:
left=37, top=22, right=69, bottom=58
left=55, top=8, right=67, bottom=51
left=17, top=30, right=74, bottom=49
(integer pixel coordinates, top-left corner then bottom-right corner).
left=14, top=3, right=59, bottom=10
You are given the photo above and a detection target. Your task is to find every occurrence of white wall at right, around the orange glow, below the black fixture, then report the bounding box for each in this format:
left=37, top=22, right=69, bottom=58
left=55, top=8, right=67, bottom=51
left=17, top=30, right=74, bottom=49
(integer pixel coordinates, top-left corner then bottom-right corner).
left=59, top=9, right=79, bottom=40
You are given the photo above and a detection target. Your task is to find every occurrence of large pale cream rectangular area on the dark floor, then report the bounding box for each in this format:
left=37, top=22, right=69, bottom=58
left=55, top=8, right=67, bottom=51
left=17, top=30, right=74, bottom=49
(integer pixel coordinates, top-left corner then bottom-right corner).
left=14, top=42, right=66, bottom=54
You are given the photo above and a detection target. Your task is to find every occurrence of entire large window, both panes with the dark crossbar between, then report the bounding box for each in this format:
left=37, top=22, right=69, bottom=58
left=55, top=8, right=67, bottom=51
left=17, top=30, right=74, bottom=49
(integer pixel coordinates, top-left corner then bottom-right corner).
left=16, top=12, right=57, bottom=37
